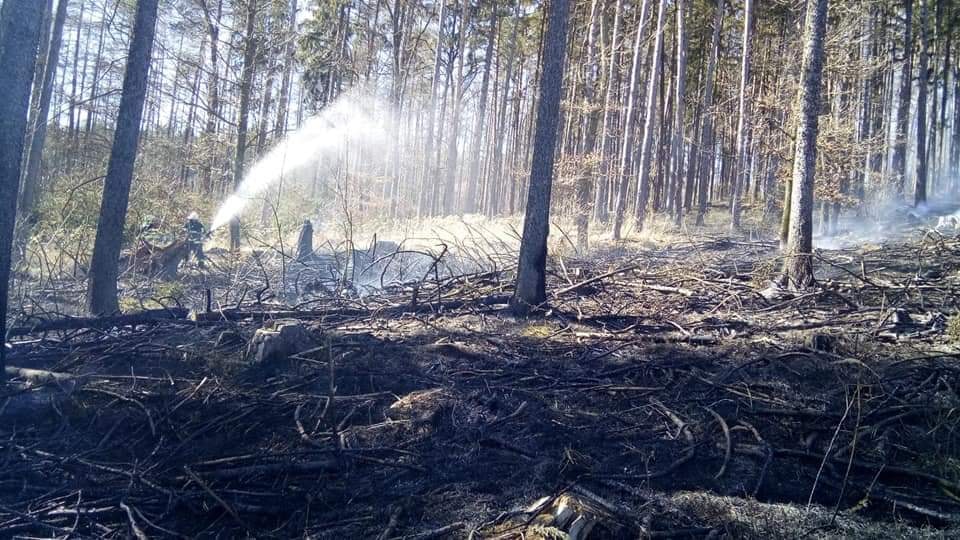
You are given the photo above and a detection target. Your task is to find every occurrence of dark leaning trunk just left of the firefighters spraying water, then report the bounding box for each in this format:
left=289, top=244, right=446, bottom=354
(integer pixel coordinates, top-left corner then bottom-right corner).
left=87, top=0, right=158, bottom=315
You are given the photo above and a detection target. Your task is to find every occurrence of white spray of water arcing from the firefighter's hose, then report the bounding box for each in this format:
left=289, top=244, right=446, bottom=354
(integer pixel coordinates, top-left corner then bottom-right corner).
left=210, top=91, right=393, bottom=230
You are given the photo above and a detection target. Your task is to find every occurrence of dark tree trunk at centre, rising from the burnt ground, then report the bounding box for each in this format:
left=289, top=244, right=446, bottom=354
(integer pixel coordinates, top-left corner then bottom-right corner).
left=510, top=0, right=570, bottom=315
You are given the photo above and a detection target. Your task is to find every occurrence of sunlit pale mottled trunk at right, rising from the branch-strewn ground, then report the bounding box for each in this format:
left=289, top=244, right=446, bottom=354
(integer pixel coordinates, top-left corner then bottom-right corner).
left=783, top=0, right=827, bottom=289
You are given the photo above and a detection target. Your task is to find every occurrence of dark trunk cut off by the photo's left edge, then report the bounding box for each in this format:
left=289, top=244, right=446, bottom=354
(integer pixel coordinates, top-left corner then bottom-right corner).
left=0, top=0, right=44, bottom=383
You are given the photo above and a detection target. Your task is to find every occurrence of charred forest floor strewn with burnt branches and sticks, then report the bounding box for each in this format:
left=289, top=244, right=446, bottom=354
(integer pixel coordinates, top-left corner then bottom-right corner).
left=0, top=209, right=960, bottom=539
